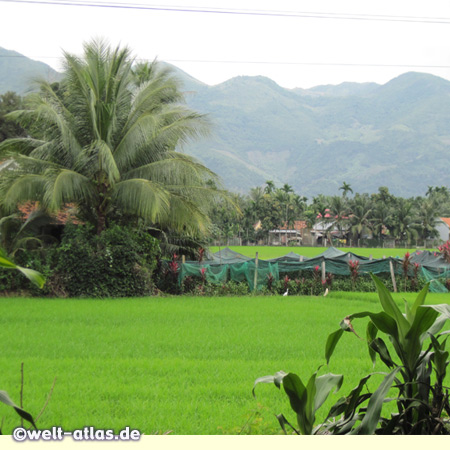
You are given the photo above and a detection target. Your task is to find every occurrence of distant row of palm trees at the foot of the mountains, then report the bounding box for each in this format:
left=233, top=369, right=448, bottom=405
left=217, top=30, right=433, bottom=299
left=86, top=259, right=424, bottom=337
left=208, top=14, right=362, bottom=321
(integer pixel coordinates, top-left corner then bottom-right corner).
left=211, top=180, right=450, bottom=246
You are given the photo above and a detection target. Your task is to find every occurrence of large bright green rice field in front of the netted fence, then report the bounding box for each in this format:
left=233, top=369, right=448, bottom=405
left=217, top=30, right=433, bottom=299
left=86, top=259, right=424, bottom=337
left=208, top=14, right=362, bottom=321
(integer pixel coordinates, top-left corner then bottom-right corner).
left=0, top=292, right=448, bottom=435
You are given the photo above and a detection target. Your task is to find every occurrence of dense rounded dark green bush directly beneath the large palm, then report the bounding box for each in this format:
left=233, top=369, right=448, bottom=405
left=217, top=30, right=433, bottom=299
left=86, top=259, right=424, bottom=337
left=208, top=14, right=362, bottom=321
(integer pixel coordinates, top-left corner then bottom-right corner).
left=49, top=225, right=159, bottom=297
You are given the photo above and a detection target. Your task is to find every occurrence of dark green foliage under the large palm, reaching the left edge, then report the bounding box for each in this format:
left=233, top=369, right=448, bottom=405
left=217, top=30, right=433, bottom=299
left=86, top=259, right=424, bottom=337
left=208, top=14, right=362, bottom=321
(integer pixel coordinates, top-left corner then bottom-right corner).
left=0, top=224, right=160, bottom=298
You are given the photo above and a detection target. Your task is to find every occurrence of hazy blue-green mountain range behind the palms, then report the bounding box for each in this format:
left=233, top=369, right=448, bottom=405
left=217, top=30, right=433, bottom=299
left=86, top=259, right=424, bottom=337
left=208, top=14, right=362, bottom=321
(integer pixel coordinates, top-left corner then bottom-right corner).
left=0, top=48, right=450, bottom=197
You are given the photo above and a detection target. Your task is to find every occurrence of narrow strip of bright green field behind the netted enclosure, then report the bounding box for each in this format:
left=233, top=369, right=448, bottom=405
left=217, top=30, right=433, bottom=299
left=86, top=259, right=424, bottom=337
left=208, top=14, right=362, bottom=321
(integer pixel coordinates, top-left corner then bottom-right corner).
left=209, top=245, right=428, bottom=259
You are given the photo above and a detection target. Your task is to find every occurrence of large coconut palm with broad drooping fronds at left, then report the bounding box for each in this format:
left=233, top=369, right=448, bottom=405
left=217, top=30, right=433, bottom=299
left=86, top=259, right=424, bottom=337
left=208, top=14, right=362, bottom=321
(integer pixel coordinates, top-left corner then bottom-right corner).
left=0, top=40, right=219, bottom=233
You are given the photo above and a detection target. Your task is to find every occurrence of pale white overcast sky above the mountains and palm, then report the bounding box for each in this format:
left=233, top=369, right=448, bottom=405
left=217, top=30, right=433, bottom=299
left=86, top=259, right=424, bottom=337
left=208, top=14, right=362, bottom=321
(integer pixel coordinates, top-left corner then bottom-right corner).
left=0, top=0, right=450, bottom=88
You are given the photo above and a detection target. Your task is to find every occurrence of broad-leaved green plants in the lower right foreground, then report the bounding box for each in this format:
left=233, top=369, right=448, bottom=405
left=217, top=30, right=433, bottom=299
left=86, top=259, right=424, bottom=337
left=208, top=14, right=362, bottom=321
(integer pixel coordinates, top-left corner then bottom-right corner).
left=253, top=275, right=450, bottom=435
